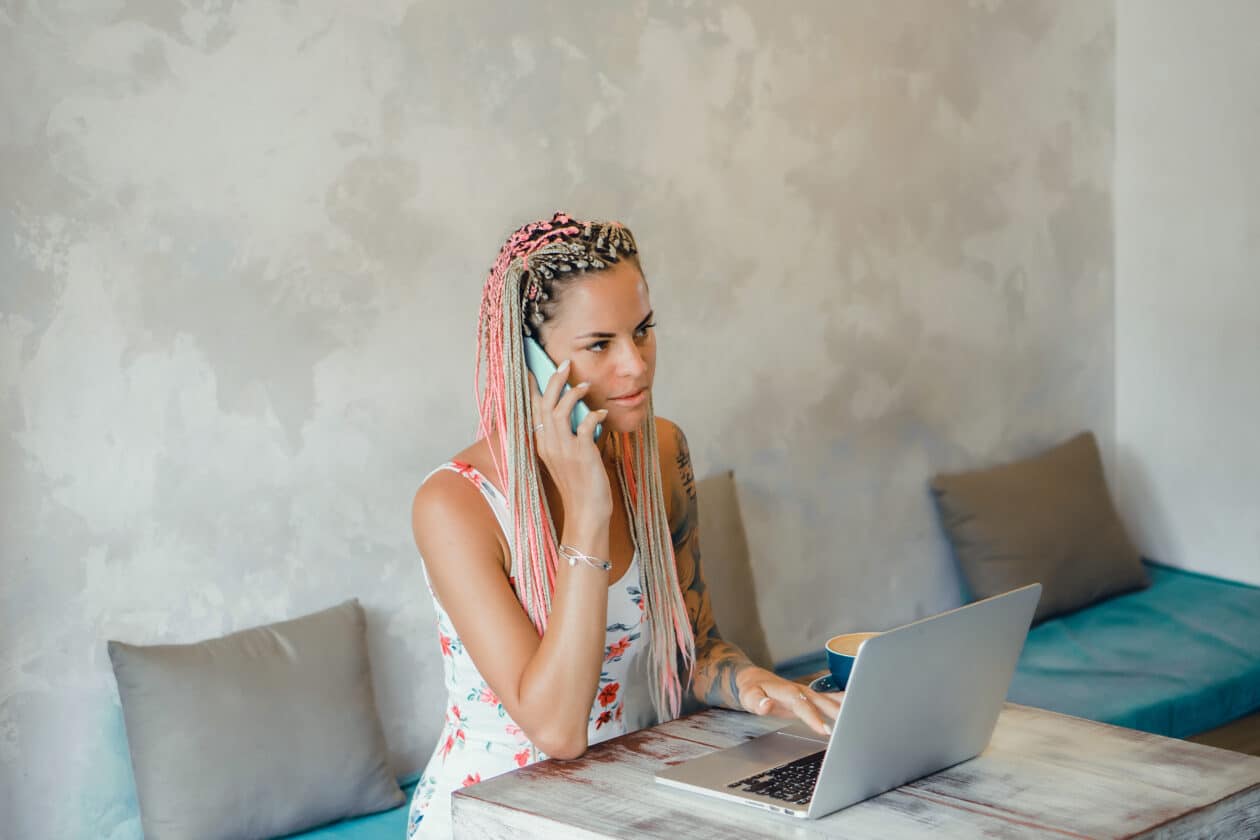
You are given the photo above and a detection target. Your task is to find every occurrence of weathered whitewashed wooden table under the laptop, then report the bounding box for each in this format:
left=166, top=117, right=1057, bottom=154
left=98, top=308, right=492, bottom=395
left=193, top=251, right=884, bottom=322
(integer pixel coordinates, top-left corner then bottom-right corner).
left=454, top=703, right=1260, bottom=840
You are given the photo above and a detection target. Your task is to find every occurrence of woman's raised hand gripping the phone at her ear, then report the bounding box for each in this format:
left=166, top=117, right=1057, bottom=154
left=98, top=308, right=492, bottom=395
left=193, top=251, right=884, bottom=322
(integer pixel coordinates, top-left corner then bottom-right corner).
left=529, top=361, right=612, bottom=531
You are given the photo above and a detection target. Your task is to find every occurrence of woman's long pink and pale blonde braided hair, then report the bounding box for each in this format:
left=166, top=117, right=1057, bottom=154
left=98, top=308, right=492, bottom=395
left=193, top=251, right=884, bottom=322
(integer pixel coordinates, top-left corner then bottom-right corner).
left=475, top=213, right=696, bottom=720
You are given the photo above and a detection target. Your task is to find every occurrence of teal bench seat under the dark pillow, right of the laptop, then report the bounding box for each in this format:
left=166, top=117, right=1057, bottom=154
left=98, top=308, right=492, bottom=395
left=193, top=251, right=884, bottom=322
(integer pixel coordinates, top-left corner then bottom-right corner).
left=1007, top=562, right=1260, bottom=738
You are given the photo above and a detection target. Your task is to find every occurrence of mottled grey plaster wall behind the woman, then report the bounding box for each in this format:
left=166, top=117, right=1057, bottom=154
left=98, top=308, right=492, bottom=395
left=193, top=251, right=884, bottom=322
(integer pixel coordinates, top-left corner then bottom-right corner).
left=0, top=0, right=1114, bottom=837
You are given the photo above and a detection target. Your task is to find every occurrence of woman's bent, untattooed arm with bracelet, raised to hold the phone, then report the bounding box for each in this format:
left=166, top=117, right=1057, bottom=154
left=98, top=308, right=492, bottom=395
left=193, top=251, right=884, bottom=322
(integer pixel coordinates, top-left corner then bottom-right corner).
left=412, top=370, right=611, bottom=758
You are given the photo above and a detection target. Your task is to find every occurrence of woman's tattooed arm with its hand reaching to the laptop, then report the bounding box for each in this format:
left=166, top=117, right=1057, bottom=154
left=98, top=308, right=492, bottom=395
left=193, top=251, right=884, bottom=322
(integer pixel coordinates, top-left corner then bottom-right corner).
left=656, top=418, right=840, bottom=734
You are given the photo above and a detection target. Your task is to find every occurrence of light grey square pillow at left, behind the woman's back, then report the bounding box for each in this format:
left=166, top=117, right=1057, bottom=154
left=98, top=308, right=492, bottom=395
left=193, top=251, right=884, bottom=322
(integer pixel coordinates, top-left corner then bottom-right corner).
left=108, top=599, right=403, bottom=840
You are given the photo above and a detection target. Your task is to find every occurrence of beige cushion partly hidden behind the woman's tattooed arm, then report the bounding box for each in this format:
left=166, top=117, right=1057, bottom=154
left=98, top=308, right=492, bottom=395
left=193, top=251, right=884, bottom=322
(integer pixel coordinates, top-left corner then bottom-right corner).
left=697, top=471, right=770, bottom=667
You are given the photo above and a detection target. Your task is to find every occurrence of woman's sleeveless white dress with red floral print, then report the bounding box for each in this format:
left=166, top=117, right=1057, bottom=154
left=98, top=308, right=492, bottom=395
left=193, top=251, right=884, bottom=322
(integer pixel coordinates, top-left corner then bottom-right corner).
left=407, top=461, right=654, bottom=840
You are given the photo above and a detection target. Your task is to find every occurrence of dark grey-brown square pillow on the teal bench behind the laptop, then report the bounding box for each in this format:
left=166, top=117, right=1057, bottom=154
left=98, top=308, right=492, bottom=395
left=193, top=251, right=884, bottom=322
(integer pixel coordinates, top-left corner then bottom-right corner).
left=931, top=432, right=1149, bottom=623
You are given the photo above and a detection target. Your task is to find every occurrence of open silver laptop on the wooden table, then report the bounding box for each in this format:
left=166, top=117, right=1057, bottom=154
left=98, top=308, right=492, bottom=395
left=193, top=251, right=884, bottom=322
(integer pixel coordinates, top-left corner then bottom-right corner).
left=656, top=583, right=1041, bottom=820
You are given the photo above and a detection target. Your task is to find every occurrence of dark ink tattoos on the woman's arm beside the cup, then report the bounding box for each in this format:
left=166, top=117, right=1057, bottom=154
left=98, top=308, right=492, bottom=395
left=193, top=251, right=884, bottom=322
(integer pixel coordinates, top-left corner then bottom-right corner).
left=669, top=427, right=752, bottom=709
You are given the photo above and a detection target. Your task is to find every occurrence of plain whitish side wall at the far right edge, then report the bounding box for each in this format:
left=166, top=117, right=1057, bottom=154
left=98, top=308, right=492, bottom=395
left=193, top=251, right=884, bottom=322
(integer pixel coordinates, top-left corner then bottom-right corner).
left=1115, top=0, right=1260, bottom=586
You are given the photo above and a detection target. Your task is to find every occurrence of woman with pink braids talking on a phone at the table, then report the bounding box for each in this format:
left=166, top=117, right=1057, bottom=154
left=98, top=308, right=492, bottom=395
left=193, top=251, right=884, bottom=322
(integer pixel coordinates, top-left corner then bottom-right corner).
left=408, top=213, right=839, bottom=837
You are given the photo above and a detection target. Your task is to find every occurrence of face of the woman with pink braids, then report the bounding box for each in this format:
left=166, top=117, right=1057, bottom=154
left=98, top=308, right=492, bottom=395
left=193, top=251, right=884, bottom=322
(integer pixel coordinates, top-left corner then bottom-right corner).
left=541, top=258, right=656, bottom=432
